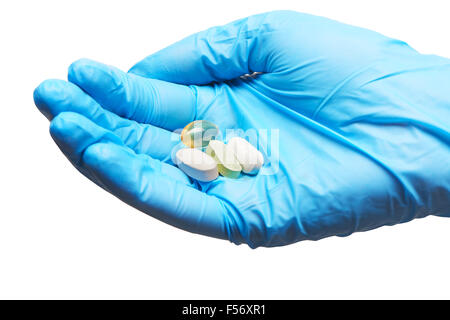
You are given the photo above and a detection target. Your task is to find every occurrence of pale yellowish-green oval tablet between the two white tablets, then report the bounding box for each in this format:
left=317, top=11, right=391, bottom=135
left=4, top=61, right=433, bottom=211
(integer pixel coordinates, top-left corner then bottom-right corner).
left=206, top=140, right=242, bottom=178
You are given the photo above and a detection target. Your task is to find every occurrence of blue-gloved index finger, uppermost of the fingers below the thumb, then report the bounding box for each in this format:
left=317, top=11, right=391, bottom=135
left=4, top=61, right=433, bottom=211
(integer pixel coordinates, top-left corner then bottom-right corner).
left=68, top=59, right=196, bottom=130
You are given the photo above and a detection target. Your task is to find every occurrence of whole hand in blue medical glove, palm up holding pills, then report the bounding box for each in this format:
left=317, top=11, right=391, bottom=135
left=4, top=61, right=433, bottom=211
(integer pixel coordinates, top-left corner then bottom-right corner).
left=34, top=11, right=450, bottom=248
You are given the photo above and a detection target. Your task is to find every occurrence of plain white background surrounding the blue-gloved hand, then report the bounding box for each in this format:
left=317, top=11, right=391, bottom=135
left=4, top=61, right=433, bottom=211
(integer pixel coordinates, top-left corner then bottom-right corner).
left=0, top=0, right=450, bottom=299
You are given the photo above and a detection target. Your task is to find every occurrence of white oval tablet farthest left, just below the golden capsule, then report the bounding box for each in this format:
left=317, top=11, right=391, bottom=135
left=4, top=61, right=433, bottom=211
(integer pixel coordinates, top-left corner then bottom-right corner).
left=174, top=148, right=219, bottom=182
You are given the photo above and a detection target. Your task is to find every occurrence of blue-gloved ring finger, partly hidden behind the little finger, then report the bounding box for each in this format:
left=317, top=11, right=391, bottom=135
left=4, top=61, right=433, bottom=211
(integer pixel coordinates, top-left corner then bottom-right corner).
left=50, top=112, right=191, bottom=185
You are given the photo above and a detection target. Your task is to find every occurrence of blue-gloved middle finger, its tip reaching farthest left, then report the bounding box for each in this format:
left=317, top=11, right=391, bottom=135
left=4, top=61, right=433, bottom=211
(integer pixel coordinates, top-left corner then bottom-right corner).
left=34, top=80, right=180, bottom=162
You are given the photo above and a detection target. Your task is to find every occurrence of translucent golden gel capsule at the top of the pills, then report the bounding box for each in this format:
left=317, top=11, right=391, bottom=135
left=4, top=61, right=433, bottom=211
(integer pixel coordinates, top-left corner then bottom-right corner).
left=181, top=120, right=219, bottom=149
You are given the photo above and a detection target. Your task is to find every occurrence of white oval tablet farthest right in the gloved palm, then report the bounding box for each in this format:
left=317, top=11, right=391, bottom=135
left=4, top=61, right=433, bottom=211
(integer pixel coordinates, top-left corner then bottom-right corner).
left=227, top=137, right=264, bottom=174
